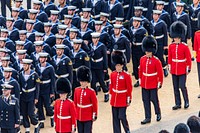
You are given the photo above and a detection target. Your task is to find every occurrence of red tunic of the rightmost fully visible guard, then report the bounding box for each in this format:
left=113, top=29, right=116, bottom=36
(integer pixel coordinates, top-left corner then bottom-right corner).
left=168, top=43, right=191, bottom=75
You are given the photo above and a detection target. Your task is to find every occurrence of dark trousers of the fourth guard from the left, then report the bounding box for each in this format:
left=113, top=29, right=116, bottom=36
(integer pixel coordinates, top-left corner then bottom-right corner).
left=142, top=88, right=161, bottom=118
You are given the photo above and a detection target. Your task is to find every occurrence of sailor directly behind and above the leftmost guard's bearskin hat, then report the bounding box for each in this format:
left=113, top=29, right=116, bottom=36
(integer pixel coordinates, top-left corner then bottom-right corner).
left=53, top=45, right=73, bottom=83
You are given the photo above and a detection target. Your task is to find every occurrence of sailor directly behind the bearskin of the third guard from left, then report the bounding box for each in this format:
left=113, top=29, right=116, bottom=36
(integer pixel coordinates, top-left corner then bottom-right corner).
left=111, top=24, right=131, bottom=70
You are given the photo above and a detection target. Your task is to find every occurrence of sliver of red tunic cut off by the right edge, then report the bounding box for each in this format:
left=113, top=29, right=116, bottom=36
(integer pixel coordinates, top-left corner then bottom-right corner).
left=194, top=31, right=200, bottom=62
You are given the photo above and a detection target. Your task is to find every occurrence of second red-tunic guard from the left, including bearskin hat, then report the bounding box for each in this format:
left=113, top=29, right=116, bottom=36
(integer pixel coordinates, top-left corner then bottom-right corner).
left=74, top=66, right=98, bottom=133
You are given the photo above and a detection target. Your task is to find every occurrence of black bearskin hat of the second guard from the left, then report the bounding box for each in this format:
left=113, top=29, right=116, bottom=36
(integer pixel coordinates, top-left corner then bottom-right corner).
left=76, top=66, right=92, bottom=82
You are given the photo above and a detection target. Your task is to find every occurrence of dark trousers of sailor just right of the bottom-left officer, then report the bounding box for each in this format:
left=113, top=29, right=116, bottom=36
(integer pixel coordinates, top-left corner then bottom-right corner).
left=20, top=100, right=38, bottom=128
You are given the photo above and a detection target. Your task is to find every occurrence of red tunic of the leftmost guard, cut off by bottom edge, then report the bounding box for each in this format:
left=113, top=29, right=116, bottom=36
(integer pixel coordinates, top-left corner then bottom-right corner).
left=54, top=99, right=76, bottom=132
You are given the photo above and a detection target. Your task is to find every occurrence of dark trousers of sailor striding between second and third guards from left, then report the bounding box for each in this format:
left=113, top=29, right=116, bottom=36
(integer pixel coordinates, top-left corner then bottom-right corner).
left=91, top=69, right=108, bottom=94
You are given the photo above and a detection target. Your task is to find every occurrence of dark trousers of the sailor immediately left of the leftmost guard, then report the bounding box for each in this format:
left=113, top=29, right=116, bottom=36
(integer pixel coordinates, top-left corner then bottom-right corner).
left=37, top=94, right=54, bottom=121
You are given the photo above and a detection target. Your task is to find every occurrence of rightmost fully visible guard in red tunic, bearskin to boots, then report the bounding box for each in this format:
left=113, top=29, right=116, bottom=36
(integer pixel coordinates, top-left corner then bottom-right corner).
left=168, top=21, right=191, bottom=110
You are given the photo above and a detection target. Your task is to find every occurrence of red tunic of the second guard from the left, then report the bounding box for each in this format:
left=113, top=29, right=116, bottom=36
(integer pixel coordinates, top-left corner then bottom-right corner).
left=74, top=87, right=98, bottom=121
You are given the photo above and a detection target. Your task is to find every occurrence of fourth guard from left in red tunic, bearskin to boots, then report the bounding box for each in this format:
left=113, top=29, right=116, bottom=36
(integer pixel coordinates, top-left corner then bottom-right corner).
left=139, top=36, right=163, bottom=124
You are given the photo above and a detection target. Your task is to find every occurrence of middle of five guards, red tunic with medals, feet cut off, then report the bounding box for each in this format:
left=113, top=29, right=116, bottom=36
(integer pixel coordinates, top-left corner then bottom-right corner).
left=110, top=51, right=132, bottom=133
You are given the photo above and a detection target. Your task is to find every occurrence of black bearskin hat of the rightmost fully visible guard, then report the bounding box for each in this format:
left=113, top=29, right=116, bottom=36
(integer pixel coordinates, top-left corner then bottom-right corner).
left=169, top=21, right=187, bottom=39
